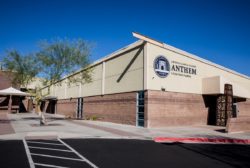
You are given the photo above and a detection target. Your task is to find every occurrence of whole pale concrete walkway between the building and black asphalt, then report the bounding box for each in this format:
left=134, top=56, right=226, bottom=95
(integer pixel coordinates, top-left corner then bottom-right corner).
left=0, top=113, right=250, bottom=140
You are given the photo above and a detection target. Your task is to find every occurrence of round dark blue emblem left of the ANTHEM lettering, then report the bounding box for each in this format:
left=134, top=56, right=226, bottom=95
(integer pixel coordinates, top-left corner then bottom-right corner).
left=154, top=56, right=170, bottom=78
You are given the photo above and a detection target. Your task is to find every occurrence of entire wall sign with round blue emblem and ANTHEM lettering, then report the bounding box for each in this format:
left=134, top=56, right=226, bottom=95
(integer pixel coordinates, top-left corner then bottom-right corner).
left=154, top=56, right=197, bottom=78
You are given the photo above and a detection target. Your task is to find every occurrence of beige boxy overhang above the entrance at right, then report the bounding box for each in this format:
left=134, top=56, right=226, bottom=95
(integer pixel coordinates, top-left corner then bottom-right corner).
left=202, top=76, right=250, bottom=98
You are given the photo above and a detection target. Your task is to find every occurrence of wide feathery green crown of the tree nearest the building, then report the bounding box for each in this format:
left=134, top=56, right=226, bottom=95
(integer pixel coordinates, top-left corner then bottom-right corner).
left=37, top=39, right=91, bottom=85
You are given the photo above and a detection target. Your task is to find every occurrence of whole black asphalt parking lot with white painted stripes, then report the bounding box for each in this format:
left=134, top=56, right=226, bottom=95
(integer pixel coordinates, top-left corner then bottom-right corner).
left=0, top=139, right=250, bottom=168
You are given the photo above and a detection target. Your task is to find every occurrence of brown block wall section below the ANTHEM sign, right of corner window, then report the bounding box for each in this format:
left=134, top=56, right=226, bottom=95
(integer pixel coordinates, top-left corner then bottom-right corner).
left=145, top=90, right=208, bottom=127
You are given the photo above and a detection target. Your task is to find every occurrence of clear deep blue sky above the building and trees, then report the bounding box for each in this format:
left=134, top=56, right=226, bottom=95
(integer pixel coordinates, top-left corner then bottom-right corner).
left=0, top=0, right=250, bottom=76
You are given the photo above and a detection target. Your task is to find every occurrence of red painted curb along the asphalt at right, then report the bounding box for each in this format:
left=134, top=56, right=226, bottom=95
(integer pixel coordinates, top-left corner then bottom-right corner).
left=154, top=137, right=250, bottom=144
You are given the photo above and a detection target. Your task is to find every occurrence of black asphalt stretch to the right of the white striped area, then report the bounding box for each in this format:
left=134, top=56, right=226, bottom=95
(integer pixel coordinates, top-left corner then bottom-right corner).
left=64, top=139, right=250, bottom=168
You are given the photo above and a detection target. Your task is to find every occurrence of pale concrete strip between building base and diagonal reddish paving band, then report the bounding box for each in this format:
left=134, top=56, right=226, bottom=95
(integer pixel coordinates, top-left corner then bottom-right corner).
left=74, top=120, right=250, bottom=139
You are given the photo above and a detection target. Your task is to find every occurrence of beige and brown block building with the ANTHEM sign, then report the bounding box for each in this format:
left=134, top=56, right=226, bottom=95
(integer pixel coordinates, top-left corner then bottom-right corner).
left=41, top=33, right=250, bottom=131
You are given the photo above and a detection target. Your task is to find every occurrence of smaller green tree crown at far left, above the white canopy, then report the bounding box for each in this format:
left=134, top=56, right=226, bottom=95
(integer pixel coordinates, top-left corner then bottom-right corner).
left=3, top=50, right=39, bottom=88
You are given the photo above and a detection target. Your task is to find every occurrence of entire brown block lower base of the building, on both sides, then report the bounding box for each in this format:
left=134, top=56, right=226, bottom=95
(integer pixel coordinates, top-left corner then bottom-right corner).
left=52, top=90, right=250, bottom=127
